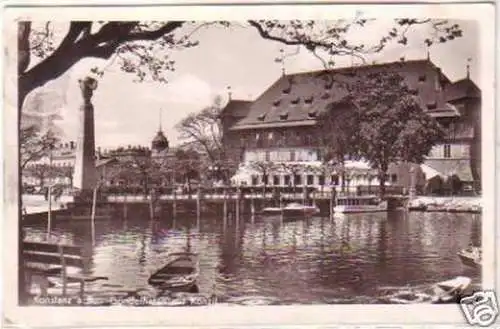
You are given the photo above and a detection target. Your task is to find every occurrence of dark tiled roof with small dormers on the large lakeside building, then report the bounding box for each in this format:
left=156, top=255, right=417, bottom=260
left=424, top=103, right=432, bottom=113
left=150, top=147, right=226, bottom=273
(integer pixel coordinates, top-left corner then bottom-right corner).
left=234, top=60, right=450, bottom=129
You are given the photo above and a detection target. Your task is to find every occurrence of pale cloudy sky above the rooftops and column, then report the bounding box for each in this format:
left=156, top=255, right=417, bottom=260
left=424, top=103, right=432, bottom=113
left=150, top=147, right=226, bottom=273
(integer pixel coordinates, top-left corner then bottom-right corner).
left=27, top=20, right=481, bottom=149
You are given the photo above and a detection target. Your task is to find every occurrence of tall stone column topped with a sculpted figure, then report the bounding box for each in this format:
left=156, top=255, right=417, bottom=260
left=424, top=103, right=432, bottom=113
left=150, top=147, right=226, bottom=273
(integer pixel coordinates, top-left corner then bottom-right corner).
left=73, top=77, right=97, bottom=198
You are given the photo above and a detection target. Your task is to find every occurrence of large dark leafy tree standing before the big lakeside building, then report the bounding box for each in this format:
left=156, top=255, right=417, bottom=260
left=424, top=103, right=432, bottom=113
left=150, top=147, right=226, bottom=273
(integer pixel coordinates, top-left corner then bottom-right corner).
left=348, top=72, right=445, bottom=194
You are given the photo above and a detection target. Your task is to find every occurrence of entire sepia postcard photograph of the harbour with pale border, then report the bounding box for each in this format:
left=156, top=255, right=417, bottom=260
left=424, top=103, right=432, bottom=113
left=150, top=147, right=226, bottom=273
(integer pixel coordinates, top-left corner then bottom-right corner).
left=4, top=1, right=498, bottom=325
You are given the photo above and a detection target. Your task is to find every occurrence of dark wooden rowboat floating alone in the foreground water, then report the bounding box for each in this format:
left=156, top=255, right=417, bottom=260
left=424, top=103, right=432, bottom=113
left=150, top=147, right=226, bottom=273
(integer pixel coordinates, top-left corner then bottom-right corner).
left=148, top=252, right=200, bottom=290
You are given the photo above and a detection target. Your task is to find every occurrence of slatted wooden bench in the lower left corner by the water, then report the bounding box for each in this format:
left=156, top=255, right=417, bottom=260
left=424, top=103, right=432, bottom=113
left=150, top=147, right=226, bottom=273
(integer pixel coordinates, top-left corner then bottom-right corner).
left=22, top=241, right=108, bottom=299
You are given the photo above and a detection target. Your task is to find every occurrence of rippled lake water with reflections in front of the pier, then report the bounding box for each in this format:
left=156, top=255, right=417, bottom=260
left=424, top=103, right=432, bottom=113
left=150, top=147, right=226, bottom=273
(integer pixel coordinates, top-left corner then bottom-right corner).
left=26, top=212, right=481, bottom=304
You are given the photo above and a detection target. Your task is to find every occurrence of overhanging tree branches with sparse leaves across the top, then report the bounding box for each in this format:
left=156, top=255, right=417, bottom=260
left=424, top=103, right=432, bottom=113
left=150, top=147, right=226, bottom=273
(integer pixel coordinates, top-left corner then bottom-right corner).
left=18, top=17, right=462, bottom=108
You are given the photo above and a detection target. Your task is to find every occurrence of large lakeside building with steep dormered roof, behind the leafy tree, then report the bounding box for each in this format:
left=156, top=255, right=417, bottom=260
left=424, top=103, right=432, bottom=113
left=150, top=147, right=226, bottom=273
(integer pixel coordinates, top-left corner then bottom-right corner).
left=221, top=59, right=481, bottom=193
